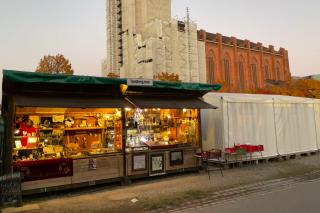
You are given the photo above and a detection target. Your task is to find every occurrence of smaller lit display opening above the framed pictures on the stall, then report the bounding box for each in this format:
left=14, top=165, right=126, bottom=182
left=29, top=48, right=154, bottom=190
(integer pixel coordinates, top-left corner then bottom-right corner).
left=126, top=109, right=199, bottom=149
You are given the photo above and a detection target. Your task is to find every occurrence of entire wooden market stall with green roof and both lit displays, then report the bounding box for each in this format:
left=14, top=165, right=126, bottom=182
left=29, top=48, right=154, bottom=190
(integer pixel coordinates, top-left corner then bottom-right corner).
left=1, top=70, right=220, bottom=193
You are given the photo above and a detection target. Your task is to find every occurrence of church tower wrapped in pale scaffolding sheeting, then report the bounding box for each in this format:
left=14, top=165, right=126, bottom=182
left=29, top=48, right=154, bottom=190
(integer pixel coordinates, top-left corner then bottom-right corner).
left=103, top=0, right=205, bottom=82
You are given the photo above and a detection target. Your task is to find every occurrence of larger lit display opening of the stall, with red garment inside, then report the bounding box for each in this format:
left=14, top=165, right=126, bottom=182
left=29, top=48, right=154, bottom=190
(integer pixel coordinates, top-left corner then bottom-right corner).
left=13, top=107, right=122, bottom=160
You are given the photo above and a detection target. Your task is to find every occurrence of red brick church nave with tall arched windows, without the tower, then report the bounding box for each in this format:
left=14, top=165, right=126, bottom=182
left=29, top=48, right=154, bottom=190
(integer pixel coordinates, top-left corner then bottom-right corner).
left=198, top=30, right=291, bottom=92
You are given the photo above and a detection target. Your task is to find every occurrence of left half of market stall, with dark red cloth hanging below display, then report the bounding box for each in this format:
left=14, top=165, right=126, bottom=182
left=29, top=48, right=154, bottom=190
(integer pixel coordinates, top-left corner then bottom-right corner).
left=2, top=71, right=134, bottom=193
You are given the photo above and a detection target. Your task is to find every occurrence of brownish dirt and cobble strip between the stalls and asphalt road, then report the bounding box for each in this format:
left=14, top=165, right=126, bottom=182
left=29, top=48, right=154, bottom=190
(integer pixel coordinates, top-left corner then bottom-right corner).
left=3, top=155, right=320, bottom=213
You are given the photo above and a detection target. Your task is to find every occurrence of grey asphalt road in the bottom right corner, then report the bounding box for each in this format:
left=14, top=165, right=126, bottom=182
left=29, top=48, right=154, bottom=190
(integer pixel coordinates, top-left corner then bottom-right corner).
left=195, top=180, right=320, bottom=213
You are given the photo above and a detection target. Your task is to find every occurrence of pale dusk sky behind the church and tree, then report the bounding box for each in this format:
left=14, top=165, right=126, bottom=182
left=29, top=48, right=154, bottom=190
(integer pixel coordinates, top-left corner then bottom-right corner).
left=0, top=0, right=320, bottom=79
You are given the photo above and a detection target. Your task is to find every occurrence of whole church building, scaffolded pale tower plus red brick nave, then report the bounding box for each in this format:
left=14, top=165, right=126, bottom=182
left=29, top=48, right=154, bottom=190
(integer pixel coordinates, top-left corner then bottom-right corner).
left=102, top=0, right=291, bottom=92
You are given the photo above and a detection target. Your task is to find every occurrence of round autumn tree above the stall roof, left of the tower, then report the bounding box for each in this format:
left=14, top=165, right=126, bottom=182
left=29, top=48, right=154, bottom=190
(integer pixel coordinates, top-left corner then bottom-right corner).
left=36, top=54, right=74, bottom=75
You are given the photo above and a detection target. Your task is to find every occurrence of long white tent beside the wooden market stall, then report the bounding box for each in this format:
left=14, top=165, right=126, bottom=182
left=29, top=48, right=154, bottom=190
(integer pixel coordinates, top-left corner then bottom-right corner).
left=201, top=93, right=320, bottom=157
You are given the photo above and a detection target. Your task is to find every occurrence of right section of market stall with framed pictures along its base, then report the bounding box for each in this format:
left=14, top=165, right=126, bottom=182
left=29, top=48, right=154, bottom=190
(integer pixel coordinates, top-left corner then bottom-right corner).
left=124, top=82, right=220, bottom=177
